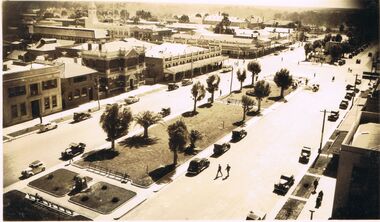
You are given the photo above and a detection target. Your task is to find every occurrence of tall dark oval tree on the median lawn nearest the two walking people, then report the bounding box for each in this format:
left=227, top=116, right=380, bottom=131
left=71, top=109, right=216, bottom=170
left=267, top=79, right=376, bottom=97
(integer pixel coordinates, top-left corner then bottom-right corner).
left=167, top=120, right=189, bottom=165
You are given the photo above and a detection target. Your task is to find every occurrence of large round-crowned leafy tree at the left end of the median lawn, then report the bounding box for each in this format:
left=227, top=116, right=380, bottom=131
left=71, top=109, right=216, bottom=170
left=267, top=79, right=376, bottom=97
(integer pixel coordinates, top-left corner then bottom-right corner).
left=100, top=103, right=133, bottom=149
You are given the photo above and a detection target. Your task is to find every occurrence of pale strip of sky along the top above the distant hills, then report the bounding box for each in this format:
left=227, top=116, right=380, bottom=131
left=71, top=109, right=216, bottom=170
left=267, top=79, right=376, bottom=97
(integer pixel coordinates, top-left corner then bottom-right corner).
left=117, top=0, right=360, bottom=8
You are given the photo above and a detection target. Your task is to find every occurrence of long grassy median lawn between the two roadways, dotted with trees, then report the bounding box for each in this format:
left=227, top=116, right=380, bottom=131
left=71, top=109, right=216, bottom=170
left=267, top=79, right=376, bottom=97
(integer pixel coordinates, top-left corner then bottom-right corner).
left=76, top=102, right=250, bottom=186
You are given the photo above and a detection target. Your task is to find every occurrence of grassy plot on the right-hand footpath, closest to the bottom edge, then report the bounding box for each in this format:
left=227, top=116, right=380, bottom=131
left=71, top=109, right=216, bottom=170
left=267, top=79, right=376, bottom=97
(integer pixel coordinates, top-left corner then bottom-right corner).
left=275, top=198, right=306, bottom=220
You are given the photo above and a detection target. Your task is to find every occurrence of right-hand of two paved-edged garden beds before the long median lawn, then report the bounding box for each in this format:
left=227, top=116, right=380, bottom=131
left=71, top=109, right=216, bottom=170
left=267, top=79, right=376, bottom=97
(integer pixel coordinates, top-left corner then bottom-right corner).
left=69, top=182, right=136, bottom=214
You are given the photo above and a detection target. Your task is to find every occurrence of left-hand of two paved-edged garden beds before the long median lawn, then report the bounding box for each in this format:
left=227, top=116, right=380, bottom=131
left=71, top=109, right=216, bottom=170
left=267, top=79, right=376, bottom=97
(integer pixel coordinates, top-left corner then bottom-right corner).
left=28, top=169, right=92, bottom=197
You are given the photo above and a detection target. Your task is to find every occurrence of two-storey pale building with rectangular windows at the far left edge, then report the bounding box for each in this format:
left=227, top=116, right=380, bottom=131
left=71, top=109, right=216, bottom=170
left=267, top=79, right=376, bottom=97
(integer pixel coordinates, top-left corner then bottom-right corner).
left=3, top=61, right=62, bottom=126
